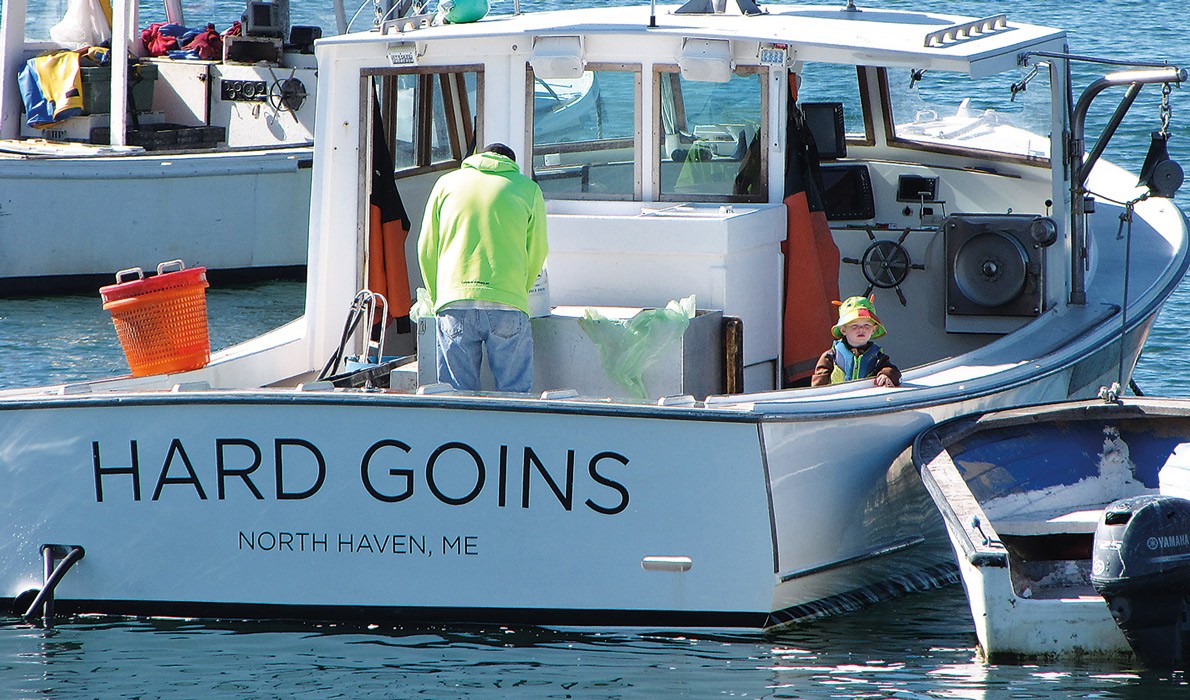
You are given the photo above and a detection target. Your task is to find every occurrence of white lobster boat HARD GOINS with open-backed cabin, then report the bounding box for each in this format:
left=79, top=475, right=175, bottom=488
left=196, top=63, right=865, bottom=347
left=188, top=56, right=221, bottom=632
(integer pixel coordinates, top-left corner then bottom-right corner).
left=0, top=0, right=1190, bottom=630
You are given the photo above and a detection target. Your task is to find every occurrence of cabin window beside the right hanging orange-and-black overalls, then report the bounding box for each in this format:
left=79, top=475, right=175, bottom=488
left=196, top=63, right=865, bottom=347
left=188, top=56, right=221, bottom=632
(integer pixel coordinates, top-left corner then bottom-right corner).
left=655, top=67, right=768, bottom=201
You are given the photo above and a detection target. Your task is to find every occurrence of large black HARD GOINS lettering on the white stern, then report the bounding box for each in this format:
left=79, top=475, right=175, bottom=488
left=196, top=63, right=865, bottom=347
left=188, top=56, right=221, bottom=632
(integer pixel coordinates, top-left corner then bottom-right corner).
left=90, top=438, right=628, bottom=515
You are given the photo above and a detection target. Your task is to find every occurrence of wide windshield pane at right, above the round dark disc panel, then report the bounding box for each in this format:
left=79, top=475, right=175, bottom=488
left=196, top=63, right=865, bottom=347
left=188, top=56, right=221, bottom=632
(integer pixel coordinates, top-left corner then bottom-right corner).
left=882, top=69, right=1052, bottom=163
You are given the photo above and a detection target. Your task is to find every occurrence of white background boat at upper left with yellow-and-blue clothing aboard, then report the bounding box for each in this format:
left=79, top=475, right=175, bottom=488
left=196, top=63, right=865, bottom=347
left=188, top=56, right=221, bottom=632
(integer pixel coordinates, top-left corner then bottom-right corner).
left=0, top=0, right=326, bottom=294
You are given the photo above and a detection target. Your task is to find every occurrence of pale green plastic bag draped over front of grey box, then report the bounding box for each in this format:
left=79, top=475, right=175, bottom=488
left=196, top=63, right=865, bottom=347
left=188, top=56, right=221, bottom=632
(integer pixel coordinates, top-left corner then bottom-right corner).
left=578, top=294, right=695, bottom=399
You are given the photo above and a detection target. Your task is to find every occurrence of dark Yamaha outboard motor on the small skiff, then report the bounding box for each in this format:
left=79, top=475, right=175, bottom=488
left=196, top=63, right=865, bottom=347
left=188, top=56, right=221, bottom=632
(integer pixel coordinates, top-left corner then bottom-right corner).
left=1091, top=495, right=1190, bottom=668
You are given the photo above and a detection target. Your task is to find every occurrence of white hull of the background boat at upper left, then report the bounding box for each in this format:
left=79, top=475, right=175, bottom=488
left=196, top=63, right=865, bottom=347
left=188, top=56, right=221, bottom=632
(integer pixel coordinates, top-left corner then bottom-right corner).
left=0, top=148, right=312, bottom=293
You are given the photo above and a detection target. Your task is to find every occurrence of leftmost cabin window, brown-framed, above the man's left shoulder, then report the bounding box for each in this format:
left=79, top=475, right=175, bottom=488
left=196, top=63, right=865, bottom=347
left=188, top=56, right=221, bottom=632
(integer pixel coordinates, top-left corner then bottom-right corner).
left=370, top=69, right=482, bottom=174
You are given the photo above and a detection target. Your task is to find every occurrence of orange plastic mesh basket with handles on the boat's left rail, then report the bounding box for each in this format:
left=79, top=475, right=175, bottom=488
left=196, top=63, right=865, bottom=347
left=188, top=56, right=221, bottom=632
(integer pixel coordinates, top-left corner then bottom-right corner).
left=99, top=261, right=211, bottom=376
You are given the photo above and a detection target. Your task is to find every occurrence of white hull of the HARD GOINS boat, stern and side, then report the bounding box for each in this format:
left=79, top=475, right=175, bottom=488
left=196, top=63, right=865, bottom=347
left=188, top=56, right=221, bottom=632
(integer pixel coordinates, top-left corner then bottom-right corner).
left=0, top=319, right=1142, bottom=629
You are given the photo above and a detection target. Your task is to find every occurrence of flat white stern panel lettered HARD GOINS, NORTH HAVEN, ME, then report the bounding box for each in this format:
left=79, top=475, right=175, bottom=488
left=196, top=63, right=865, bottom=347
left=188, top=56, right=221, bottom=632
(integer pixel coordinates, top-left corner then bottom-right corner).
left=0, top=394, right=772, bottom=625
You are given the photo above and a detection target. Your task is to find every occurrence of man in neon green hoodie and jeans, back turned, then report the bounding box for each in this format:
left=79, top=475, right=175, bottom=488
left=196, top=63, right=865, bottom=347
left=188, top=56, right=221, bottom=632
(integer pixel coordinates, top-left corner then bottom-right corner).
left=418, top=143, right=549, bottom=392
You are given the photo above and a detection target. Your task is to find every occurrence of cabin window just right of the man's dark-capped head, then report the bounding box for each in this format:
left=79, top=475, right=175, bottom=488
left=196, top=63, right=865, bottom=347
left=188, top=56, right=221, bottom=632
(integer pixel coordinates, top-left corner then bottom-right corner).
left=526, top=64, right=641, bottom=200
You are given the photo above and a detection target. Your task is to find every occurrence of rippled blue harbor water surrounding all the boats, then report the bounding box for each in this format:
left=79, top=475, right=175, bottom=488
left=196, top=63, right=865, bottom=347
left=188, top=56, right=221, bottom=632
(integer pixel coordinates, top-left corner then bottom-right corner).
left=0, top=0, right=1190, bottom=700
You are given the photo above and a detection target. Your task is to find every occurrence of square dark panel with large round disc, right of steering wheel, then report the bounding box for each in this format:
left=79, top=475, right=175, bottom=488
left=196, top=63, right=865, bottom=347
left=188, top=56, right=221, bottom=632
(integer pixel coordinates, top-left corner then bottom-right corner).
left=942, top=214, right=1057, bottom=315
